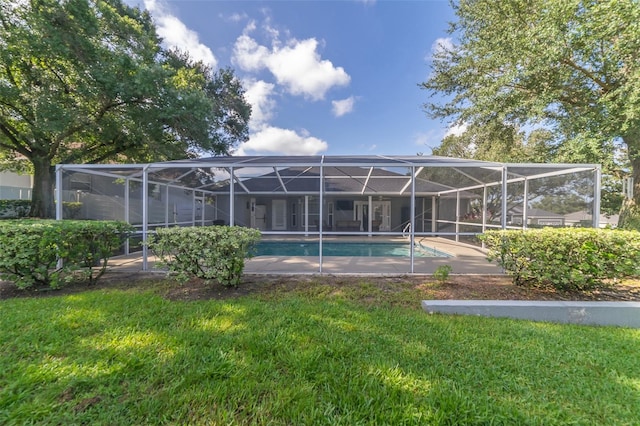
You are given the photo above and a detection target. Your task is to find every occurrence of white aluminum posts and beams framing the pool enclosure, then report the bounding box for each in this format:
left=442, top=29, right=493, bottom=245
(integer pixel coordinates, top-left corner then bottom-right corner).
left=55, top=155, right=601, bottom=273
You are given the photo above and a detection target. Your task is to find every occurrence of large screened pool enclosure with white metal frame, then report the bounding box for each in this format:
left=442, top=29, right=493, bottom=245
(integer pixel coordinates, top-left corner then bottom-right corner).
left=56, top=156, right=600, bottom=272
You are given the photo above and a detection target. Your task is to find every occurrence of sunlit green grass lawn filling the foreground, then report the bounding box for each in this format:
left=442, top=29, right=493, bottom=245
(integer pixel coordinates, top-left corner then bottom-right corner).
left=0, top=282, right=640, bottom=425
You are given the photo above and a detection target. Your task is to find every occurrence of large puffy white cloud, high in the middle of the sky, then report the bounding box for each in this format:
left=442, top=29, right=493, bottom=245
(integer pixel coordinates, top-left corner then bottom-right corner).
left=232, top=23, right=351, bottom=100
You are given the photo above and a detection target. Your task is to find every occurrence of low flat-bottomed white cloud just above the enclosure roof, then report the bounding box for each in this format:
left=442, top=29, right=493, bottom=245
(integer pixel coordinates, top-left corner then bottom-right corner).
left=234, top=127, right=328, bottom=155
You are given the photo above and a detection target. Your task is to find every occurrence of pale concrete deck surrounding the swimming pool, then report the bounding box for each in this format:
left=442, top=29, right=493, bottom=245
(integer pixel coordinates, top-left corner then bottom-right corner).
left=109, top=237, right=502, bottom=275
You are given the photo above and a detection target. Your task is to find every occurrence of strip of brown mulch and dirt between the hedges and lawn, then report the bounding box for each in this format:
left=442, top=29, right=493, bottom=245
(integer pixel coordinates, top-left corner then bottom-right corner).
left=0, top=273, right=640, bottom=301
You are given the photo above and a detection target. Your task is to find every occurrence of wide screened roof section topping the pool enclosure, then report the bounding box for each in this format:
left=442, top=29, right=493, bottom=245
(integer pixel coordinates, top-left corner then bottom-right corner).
left=57, top=155, right=599, bottom=195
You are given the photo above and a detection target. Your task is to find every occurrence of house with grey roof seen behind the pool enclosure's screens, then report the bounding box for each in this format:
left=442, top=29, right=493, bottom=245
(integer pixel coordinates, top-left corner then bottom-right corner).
left=212, top=166, right=458, bottom=232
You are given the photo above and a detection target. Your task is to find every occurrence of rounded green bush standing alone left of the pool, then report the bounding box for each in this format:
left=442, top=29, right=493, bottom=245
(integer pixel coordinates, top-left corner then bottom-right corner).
left=147, top=226, right=261, bottom=286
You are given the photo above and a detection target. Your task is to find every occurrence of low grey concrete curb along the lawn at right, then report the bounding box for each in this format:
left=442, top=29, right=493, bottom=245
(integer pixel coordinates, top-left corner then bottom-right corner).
left=422, top=300, right=640, bottom=328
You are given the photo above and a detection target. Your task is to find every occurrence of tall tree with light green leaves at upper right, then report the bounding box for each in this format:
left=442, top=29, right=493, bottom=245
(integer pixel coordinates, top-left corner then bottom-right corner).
left=421, top=0, right=640, bottom=220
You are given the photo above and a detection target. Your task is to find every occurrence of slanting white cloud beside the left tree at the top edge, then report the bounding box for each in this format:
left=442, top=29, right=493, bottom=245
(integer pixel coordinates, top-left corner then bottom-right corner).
left=144, top=0, right=218, bottom=68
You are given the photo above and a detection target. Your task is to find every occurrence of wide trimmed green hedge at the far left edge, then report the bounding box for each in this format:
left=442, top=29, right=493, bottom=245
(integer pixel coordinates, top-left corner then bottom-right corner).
left=0, top=220, right=133, bottom=288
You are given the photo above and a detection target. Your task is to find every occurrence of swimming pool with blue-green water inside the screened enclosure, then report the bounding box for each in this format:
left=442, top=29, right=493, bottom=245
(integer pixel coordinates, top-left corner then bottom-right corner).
left=255, top=241, right=451, bottom=257
